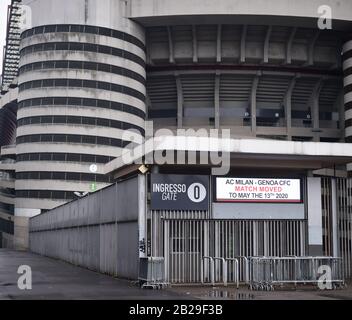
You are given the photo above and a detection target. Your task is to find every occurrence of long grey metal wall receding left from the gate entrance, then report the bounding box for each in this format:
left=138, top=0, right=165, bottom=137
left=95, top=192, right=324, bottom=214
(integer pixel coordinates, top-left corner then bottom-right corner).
left=30, top=178, right=138, bottom=279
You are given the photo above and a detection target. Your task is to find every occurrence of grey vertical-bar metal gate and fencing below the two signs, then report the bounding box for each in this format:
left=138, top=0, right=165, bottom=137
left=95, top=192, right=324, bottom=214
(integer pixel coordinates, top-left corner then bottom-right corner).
left=148, top=211, right=306, bottom=283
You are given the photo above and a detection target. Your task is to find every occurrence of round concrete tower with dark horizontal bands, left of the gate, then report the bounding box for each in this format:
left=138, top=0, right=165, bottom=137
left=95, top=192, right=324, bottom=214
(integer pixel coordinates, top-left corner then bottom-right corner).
left=16, top=0, right=146, bottom=215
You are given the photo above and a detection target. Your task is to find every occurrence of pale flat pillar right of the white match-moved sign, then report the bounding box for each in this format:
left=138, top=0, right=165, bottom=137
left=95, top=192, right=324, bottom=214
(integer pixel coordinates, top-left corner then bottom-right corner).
left=307, top=177, right=323, bottom=256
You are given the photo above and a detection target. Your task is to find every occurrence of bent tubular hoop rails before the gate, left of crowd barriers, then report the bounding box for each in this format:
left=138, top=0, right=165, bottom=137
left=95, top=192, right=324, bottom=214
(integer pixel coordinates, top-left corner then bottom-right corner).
left=201, top=256, right=239, bottom=288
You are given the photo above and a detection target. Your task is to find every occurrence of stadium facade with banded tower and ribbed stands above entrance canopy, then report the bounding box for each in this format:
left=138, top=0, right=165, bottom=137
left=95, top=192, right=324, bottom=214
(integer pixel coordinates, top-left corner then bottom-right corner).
left=0, top=0, right=352, bottom=251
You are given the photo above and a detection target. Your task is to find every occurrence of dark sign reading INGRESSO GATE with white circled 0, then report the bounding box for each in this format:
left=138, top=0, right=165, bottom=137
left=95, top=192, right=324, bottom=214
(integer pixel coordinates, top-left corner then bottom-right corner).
left=150, top=174, right=209, bottom=210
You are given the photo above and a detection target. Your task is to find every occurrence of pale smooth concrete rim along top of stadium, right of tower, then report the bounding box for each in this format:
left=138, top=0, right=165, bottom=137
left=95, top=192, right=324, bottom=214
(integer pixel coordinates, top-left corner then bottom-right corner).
left=129, top=0, right=352, bottom=30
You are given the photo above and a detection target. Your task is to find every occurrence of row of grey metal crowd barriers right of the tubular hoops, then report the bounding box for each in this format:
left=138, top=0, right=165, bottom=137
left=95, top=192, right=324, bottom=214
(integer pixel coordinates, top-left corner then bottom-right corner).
left=249, top=256, right=345, bottom=290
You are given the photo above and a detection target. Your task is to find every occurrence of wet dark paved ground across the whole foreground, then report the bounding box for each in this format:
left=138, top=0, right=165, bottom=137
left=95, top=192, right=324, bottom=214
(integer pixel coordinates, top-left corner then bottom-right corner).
left=0, top=249, right=352, bottom=300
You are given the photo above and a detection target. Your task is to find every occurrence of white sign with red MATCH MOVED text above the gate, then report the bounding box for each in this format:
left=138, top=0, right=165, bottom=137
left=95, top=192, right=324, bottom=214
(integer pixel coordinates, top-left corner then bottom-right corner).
left=216, top=178, right=302, bottom=203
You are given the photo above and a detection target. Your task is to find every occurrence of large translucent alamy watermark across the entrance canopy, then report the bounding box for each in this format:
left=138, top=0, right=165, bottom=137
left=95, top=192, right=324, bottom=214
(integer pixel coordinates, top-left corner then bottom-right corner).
left=121, top=121, right=231, bottom=175
